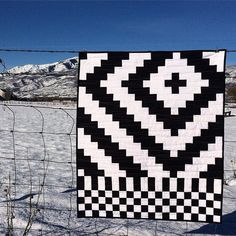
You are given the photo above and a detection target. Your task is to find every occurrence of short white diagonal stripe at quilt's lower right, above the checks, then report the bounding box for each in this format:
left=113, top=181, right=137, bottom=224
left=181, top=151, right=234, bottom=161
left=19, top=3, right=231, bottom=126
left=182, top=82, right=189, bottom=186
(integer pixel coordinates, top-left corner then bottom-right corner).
left=177, top=137, right=223, bottom=179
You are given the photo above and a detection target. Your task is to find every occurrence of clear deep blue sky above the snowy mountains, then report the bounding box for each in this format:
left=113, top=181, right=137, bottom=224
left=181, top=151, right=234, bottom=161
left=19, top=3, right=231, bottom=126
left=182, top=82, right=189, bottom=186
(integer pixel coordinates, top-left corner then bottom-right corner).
left=0, top=0, right=236, bottom=67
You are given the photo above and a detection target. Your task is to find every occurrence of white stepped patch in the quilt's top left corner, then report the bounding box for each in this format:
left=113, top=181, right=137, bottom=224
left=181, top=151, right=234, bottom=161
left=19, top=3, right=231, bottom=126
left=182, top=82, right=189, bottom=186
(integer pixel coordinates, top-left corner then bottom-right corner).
left=79, top=53, right=107, bottom=80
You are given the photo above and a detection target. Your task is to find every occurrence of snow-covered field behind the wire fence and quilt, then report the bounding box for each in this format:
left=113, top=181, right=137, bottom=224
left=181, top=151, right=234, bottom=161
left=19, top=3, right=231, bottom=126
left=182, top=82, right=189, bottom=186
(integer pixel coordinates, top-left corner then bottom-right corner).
left=0, top=102, right=236, bottom=236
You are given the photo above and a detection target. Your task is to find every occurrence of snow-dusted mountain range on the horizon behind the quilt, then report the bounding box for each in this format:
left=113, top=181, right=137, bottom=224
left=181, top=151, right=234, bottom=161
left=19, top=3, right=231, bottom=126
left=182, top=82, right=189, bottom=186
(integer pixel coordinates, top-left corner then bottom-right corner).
left=0, top=57, right=236, bottom=100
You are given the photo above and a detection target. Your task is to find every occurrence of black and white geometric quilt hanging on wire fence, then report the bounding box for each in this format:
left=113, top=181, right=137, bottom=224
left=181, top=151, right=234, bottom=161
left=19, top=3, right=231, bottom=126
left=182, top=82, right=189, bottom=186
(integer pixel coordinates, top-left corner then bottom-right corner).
left=77, top=50, right=225, bottom=222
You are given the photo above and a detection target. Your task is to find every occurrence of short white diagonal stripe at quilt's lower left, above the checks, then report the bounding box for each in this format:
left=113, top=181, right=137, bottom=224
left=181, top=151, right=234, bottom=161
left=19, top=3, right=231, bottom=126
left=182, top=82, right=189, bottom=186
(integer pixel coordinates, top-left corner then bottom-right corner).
left=78, top=128, right=126, bottom=177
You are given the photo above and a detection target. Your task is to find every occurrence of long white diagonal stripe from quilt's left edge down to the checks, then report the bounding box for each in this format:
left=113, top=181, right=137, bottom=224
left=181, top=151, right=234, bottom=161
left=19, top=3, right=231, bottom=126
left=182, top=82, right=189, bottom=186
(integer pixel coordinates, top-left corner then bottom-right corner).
left=79, top=87, right=169, bottom=178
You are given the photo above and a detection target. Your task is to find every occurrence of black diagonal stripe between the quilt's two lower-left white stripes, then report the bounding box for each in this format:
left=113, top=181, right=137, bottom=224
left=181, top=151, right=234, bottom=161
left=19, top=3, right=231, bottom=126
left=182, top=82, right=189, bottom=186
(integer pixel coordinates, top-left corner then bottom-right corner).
left=77, top=108, right=147, bottom=177
